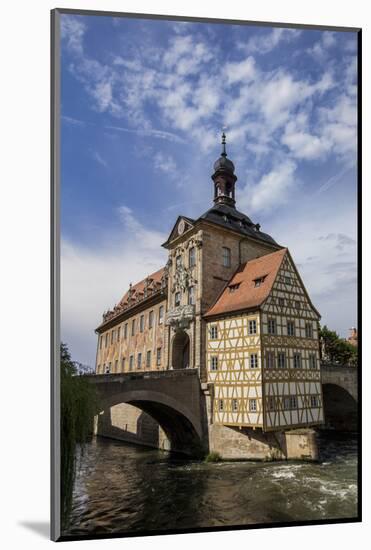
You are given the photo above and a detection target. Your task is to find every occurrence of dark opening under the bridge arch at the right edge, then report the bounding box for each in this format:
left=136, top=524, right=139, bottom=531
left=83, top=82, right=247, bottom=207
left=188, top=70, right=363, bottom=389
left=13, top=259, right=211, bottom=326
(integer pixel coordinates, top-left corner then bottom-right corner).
left=322, top=383, right=358, bottom=431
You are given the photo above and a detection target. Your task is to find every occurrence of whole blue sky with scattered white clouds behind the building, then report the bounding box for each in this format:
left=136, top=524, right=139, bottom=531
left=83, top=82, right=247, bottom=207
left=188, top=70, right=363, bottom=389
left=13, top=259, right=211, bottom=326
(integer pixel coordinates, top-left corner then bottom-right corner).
left=61, top=15, right=357, bottom=364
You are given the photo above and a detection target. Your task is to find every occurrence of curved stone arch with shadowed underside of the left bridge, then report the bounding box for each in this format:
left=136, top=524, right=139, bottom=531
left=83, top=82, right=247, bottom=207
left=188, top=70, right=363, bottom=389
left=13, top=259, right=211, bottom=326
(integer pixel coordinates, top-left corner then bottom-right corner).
left=97, top=389, right=204, bottom=456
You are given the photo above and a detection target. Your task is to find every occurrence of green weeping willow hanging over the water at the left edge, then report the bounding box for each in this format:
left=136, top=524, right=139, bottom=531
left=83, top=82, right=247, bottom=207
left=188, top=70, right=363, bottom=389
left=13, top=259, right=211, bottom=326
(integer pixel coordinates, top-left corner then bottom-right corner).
left=61, top=343, right=98, bottom=529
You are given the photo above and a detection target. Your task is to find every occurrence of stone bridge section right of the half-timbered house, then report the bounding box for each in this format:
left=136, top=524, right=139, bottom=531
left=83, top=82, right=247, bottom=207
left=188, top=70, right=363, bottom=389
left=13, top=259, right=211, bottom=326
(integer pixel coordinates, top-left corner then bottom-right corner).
left=321, top=363, right=358, bottom=430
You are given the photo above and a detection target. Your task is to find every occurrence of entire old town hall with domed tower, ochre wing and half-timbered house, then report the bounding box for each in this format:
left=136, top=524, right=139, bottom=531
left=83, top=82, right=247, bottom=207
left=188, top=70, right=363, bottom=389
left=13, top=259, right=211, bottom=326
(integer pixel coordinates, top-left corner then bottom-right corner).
left=96, top=134, right=323, bottom=448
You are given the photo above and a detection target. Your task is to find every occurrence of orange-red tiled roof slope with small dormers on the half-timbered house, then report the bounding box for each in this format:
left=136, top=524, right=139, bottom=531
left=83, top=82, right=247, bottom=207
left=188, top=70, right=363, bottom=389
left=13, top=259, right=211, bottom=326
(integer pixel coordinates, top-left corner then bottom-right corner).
left=205, top=248, right=287, bottom=317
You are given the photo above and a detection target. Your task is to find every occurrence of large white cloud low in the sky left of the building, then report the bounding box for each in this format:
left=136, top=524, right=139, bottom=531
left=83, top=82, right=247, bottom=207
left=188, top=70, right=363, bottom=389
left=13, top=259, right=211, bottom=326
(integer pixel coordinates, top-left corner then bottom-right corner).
left=61, top=206, right=166, bottom=366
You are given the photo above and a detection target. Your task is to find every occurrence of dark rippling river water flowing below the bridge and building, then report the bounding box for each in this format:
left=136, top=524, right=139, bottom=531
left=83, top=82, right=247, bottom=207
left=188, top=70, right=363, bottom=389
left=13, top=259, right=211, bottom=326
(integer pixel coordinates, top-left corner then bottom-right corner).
left=65, top=432, right=357, bottom=535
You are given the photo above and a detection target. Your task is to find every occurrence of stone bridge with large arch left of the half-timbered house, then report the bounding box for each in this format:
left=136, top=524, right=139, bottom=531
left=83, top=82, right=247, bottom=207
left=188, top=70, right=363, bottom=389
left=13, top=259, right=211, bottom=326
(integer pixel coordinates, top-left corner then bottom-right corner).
left=87, top=369, right=208, bottom=455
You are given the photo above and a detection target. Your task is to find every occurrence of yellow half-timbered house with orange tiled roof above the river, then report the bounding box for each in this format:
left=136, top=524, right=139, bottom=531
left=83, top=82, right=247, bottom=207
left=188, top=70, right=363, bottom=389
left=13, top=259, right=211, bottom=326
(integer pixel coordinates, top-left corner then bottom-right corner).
left=205, top=249, right=323, bottom=431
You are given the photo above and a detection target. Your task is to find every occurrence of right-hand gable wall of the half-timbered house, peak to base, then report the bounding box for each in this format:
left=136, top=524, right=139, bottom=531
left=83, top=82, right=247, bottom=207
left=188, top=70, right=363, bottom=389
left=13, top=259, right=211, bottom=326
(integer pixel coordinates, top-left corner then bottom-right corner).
left=262, top=251, right=323, bottom=430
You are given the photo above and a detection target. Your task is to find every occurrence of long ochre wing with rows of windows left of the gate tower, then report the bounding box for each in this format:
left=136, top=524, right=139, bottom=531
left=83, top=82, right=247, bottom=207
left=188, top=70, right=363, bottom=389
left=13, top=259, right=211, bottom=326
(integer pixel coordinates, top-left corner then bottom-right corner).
left=96, top=269, right=167, bottom=374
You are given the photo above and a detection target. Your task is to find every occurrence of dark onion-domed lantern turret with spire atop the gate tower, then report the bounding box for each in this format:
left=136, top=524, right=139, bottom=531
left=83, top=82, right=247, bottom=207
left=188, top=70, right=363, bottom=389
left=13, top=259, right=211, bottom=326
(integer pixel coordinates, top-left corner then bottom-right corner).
left=211, top=132, right=237, bottom=207
